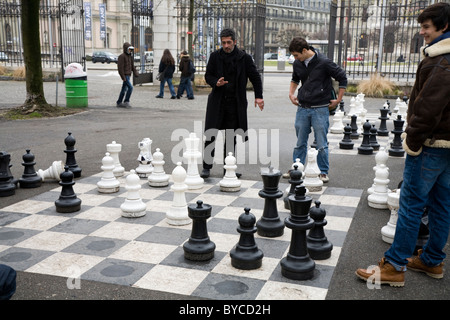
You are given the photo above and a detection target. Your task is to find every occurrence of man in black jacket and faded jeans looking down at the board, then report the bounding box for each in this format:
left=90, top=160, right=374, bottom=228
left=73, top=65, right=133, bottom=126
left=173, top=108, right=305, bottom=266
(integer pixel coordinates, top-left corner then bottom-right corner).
left=289, top=37, right=347, bottom=182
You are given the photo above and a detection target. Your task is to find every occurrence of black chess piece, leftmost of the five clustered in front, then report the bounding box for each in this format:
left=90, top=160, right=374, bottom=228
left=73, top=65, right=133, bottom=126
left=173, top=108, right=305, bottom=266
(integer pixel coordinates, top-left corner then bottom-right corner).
left=183, top=200, right=216, bottom=261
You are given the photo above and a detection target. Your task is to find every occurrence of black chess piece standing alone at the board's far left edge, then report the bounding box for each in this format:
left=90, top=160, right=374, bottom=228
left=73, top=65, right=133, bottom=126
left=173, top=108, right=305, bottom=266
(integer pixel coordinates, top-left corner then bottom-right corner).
left=55, top=165, right=81, bottom=213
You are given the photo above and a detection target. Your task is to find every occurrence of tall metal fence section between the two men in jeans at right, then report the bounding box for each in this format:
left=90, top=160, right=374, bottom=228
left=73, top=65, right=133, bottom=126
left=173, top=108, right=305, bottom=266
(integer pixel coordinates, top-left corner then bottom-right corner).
left=329, top=0, right=448, bottom=81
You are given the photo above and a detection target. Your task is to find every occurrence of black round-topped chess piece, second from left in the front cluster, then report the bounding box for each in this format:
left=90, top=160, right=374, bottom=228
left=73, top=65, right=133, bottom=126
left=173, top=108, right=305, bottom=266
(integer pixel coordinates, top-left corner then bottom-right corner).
left=230, top=208, right=264, bottom=270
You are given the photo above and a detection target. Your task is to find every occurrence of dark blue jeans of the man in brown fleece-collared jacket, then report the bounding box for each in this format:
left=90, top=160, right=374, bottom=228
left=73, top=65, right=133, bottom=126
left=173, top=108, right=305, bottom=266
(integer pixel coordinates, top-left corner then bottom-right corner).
left=385, top=147, right=450, bottom=269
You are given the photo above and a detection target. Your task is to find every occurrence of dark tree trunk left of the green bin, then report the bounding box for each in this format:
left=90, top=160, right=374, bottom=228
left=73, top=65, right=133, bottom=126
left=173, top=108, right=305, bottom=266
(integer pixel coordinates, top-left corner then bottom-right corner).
left=21, top=0, right=51, bottom=113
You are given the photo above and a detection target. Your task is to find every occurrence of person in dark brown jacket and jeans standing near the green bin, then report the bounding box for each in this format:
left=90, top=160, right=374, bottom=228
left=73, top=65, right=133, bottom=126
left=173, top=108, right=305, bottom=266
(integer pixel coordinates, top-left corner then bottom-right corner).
left=116, top=42, right=139, bottom=108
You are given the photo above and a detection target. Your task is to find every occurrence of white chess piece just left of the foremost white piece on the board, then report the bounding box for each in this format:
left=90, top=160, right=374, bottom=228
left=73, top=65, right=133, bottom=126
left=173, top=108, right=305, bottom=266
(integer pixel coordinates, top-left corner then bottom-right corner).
left=120, top=170, right=147, bottom=218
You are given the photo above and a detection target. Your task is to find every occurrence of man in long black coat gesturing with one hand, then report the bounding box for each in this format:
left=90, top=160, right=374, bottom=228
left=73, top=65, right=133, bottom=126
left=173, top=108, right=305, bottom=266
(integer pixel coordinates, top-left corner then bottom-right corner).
left=200, top=28, right=264, bottom=178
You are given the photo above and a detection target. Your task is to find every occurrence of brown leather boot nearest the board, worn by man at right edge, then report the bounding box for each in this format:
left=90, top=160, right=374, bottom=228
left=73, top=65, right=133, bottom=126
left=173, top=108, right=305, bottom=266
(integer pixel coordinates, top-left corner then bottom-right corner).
left=355, top=258, right=405, bottom=287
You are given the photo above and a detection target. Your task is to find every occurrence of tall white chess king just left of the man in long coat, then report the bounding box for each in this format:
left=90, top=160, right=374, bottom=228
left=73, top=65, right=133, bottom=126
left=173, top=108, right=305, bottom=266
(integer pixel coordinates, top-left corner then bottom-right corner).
left=183, top=132, right=204, bottom=190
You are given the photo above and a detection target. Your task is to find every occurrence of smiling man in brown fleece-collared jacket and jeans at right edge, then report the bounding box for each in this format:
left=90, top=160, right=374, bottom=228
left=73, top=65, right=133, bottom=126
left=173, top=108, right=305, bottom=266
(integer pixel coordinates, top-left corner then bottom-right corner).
left=356, top=3, right=450, bottom=287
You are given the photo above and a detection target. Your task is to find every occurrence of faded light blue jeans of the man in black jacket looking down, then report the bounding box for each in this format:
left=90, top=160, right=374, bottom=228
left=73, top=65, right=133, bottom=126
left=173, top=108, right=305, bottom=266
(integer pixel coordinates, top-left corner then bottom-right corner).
left=292, top=106, right=330, bottom=174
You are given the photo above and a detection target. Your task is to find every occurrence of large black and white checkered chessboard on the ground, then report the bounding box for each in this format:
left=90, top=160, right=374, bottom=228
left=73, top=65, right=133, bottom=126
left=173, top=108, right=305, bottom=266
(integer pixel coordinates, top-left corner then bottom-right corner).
left=0, top=172, right=362, bottom=300
